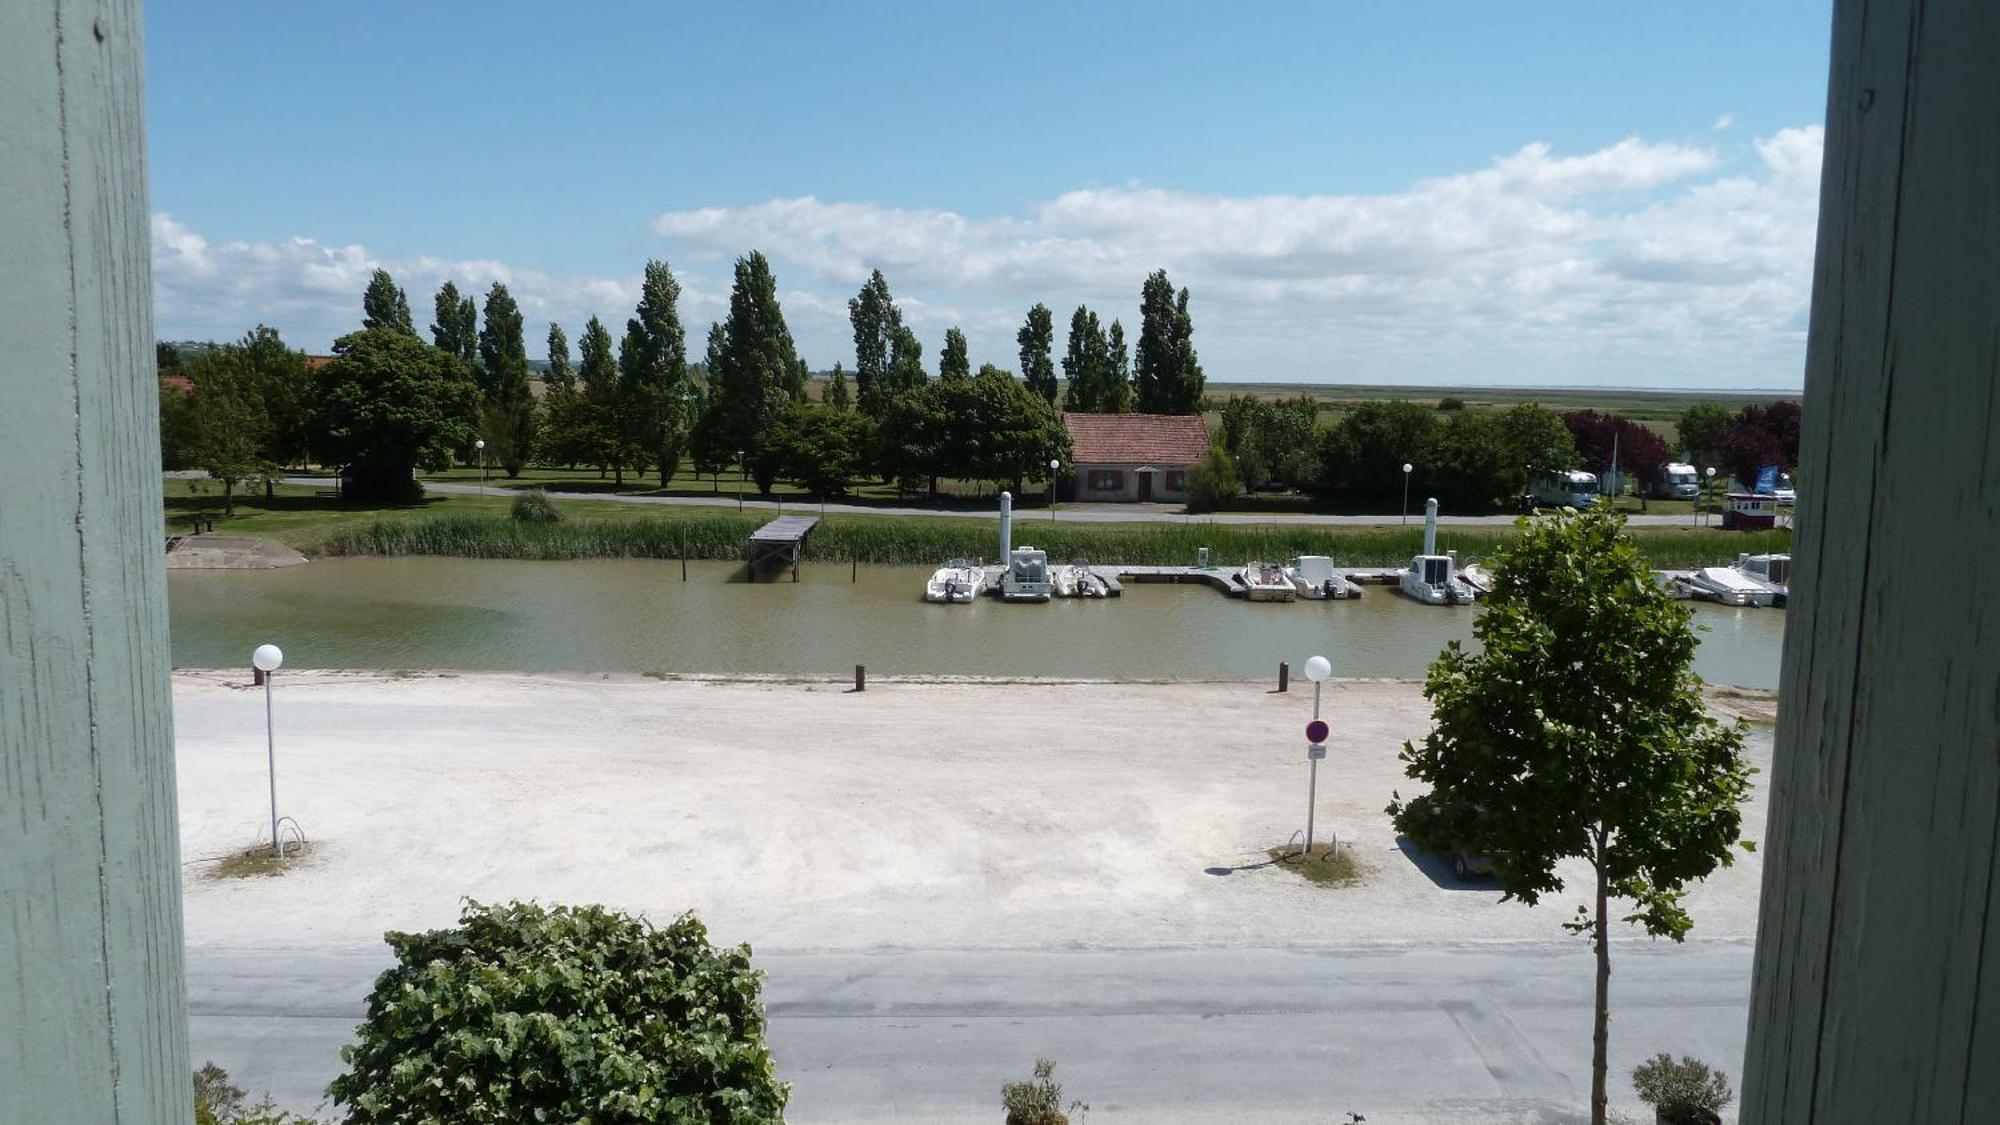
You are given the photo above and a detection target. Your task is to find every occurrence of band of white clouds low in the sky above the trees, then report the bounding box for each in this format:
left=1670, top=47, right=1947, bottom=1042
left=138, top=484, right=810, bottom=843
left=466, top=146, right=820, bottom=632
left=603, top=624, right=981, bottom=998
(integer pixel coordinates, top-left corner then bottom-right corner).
left=154, top=122, right=1822, bottom=386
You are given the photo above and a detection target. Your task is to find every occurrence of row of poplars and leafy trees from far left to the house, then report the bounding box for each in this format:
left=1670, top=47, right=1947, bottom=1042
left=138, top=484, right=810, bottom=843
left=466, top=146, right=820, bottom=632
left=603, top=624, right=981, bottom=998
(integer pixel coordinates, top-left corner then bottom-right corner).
left=160, top=252, right=1204, bottom=502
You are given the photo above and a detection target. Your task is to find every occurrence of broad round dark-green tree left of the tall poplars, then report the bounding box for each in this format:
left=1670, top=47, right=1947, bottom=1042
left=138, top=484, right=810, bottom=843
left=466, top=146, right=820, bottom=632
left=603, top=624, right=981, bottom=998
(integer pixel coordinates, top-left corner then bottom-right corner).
left=312, top=328, right=478, bottom=498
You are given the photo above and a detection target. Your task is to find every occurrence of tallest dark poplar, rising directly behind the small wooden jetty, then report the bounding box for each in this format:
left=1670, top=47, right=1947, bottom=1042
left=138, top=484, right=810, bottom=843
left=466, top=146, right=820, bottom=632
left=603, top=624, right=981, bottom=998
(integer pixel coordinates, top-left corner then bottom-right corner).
left=708, top=250, right=798, bottom=496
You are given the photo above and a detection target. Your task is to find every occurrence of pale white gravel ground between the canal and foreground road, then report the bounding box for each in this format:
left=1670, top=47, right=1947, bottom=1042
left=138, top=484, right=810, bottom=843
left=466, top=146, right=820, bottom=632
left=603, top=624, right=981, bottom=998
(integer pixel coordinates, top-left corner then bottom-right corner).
left=174, top=673, right=1770, bottom=951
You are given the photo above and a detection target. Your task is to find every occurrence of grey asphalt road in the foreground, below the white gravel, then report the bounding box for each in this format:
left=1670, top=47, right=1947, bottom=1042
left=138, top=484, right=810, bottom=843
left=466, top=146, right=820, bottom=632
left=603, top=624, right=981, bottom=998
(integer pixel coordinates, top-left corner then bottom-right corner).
left=188, top=936, right=1750, bottom=1125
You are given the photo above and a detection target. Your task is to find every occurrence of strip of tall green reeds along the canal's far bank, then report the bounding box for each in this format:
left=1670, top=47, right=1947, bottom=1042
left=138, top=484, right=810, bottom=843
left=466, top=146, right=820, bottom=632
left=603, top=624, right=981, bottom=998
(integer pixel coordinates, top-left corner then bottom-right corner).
left=308, top=512, right=1792, bottom=571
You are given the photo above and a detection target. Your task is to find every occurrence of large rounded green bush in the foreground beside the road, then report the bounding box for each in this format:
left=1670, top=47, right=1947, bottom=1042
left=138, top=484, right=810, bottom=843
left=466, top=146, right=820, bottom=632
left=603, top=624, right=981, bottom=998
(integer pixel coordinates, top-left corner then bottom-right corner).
left=328, top=903, right=790, bottom=1125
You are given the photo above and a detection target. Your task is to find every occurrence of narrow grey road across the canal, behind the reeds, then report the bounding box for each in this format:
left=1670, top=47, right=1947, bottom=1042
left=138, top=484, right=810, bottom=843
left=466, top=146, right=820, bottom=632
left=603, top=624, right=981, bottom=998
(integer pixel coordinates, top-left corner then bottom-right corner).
left=284, top=476, right=1694, bottom=526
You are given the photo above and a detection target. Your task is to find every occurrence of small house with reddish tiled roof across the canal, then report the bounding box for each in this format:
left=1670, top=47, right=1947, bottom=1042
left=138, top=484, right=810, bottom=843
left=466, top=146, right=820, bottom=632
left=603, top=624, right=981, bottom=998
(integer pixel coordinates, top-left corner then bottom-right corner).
left=1062, top=414, right=1208, bottom=502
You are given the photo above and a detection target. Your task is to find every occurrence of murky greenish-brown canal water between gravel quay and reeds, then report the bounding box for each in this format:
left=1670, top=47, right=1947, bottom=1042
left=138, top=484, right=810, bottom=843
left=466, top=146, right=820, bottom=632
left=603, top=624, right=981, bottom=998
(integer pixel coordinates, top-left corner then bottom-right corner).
left=168, top=558, right=1784, bottom=687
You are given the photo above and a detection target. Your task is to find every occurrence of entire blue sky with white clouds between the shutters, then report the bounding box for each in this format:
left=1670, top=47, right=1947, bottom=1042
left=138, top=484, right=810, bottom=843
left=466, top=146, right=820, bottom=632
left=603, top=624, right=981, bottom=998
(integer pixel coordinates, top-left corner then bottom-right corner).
left=146, top=0, right=1830, bottom=388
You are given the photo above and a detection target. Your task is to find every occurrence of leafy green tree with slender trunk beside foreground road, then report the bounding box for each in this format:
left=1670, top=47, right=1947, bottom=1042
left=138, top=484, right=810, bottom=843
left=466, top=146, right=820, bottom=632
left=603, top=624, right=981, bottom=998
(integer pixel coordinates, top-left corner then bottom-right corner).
left=1388, top=510, right=1752, bottom=1125
